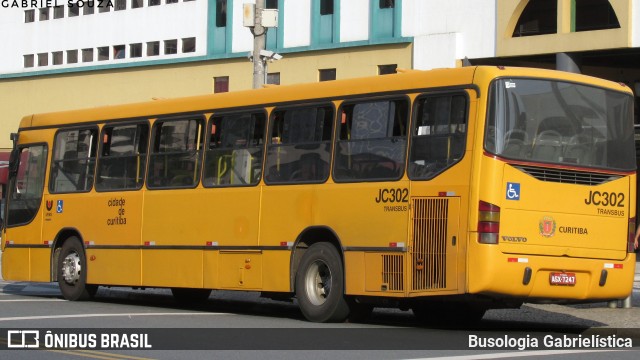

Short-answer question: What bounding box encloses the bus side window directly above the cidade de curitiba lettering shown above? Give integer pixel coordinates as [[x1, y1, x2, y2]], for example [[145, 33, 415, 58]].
[[96, 123, 149, 191]]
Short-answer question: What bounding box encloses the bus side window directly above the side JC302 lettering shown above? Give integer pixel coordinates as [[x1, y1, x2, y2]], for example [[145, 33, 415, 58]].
[[333, 99, 409, 181]]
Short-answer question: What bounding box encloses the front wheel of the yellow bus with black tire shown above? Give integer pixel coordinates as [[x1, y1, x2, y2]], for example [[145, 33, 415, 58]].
[[58, 236, 98, 301]]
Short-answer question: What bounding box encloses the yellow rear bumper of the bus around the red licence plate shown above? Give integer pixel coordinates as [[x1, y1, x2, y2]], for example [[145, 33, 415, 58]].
[[467, 245, 636, 302]]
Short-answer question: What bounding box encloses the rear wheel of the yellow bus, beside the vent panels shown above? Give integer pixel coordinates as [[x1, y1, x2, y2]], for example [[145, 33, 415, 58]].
[[295, 243, 349, 322]]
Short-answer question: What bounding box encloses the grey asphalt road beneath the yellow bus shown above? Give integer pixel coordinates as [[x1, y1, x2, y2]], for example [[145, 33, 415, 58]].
[[0, 253, 640, 359]]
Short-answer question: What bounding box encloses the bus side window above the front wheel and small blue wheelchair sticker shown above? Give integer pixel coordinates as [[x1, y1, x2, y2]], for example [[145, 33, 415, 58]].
[[49, 128, 98, 193]]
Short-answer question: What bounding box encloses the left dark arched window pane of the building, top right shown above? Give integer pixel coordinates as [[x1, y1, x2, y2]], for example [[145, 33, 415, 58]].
[[513, 0, 558, 37]]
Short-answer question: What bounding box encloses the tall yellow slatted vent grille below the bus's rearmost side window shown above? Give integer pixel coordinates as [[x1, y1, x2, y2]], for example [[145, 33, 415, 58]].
[[411, 198, 449, 290]]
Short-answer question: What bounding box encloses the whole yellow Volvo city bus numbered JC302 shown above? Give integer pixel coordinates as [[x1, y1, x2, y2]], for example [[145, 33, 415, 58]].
[[2, 67, 636, 322]]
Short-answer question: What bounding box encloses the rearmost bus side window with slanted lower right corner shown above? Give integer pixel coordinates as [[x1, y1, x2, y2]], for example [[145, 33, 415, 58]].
[[408, 94, 467, 179]]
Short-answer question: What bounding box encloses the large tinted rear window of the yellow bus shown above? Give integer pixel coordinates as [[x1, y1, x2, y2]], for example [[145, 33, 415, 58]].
[[484, 78, 636, 171]]
